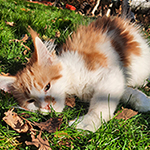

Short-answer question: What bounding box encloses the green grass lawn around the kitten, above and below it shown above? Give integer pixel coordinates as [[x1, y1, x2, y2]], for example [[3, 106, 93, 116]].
[[0, 0, 150, 150]]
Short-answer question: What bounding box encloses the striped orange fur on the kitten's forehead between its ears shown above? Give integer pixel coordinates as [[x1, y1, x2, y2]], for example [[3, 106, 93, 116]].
[[11, 60, 62, 107]]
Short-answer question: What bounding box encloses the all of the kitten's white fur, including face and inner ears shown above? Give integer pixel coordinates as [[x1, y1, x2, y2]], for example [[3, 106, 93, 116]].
[[0, 18, 150, 131]]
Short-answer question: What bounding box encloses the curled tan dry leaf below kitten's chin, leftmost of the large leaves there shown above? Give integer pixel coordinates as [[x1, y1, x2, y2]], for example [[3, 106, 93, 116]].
[[3, 109, 33, 133]]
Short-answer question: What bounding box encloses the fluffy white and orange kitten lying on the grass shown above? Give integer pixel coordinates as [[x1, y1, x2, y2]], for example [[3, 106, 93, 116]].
[[0, 17, 150, 131]]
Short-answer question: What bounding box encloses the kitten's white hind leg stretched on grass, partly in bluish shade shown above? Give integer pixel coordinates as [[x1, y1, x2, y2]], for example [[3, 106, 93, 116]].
[[121, 87, 150, 112]]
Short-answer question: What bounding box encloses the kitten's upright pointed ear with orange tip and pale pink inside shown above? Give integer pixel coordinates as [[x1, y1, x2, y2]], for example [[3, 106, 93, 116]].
[[28, 27, 55, 65]]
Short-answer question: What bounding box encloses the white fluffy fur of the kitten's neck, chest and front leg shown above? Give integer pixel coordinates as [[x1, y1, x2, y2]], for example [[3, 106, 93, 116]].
[[53, 49, 125, 131]]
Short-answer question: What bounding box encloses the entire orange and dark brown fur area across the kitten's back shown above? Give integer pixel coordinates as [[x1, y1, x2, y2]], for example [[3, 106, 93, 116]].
[[63, 17, 141, 67]]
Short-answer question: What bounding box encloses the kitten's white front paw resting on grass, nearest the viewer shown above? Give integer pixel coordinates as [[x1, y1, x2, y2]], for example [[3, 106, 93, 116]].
[[69, 115, 100, 132]]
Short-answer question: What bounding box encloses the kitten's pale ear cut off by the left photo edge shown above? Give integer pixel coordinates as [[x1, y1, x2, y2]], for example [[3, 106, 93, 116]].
[[0, 75, 16, 93]]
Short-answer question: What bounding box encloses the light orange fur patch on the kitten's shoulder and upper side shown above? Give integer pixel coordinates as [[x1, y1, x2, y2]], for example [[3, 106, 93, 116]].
[[63, 26, 108, 70]]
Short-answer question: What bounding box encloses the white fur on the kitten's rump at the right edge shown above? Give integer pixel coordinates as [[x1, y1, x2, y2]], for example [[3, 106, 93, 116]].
[[127, 30, 150, 87]]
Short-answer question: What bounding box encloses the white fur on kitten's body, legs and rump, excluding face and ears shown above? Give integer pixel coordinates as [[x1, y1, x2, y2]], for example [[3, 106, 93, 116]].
[[45, 27, 150, 131]]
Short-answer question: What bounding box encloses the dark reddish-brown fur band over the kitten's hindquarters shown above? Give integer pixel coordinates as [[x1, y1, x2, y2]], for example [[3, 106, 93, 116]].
[[90, 17, 141, 67]]
